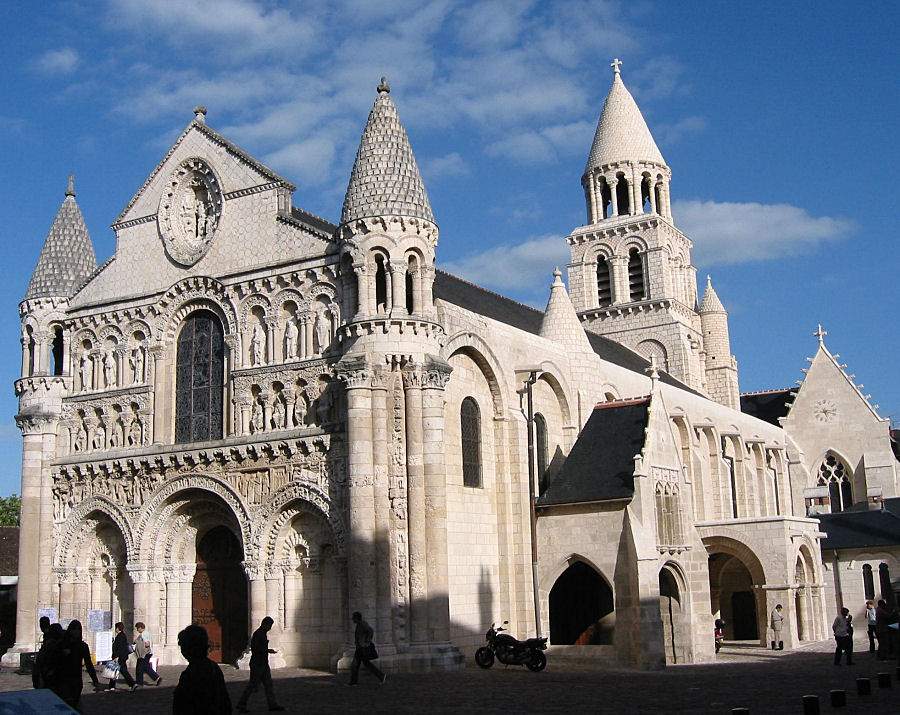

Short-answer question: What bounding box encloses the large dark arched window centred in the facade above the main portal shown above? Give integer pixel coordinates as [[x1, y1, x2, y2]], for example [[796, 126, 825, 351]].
[[175, 310, 225, 443]]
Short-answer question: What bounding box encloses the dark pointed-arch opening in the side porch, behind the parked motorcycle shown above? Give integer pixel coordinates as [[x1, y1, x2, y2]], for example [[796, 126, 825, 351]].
[[550, 561, 615, 645]]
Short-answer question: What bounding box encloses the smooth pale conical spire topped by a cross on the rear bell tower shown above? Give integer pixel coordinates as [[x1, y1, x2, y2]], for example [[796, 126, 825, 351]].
[[584, 59, 666, 174]]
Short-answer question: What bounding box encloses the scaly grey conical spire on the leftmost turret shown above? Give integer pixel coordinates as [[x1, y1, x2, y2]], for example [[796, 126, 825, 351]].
[[25, 176, 97, 300]]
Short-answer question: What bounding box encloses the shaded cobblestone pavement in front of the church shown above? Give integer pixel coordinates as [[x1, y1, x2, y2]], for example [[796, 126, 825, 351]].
[[0, 642, 900, 715]]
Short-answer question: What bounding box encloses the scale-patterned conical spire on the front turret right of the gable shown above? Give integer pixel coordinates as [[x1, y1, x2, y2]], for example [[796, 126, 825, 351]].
[[341, 77, 434, 223]]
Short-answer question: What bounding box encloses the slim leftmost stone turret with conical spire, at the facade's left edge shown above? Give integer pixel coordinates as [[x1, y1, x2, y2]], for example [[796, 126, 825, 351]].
[[4, 176, 97, 665]]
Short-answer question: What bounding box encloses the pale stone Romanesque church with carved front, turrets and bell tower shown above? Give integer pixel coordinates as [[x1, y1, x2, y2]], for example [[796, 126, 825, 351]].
[[5, 63, 897, 669]]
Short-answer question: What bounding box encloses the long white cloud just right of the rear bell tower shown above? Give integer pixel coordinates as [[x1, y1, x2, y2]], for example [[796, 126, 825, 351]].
[[672, 200, 854, 266]]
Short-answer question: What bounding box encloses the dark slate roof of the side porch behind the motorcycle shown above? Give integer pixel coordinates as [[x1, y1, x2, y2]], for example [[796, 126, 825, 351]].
[[537, 397, 650, 507]]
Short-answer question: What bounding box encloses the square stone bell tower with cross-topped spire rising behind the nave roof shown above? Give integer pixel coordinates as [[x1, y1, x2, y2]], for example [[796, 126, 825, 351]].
[[567, 59, 706, 390]]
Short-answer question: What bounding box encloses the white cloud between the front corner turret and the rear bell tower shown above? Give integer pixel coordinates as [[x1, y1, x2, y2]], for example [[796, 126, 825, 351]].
[[441, 235, 569, 301]]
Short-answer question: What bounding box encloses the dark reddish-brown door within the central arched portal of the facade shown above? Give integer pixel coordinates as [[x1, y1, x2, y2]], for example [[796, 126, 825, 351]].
[[191, 526, 247, 663]]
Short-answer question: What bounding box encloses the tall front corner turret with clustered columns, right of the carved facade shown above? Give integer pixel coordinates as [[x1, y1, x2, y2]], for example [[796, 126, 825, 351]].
[[336, 78, 462, 670]]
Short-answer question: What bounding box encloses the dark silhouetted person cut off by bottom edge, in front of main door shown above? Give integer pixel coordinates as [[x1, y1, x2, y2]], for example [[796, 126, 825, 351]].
[[172, 625, 231, 715]]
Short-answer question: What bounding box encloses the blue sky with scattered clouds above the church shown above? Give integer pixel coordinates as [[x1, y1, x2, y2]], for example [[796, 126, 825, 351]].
[[0, 0, 900, 493]]
